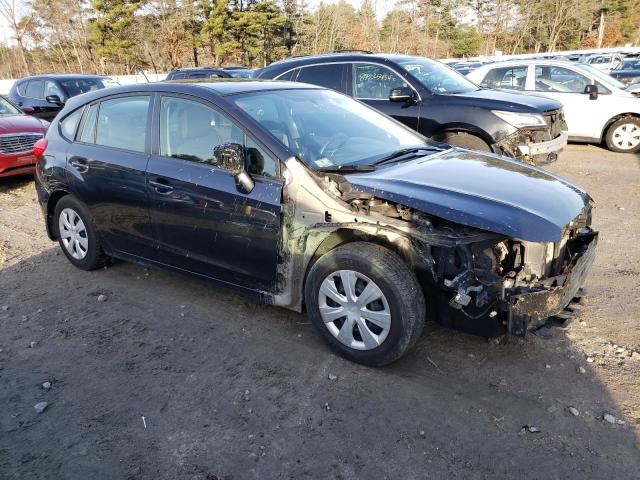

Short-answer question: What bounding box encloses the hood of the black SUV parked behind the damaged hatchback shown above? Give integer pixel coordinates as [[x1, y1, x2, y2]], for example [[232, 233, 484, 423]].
[[456, 88, 562, 113]]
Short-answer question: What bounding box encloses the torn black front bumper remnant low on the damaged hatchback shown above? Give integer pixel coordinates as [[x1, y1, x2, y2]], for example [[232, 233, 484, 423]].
[[503, 231, 598, 336]]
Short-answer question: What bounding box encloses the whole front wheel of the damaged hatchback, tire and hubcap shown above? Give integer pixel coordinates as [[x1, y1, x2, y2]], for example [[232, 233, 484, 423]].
[[305, 242, 425, 366]]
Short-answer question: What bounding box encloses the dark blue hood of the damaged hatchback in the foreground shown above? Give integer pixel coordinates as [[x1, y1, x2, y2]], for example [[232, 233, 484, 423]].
[[345, 148, 591, 242]]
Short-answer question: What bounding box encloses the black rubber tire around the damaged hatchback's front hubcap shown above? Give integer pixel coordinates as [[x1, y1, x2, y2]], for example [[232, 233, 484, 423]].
[[305, 242, 426, 367]]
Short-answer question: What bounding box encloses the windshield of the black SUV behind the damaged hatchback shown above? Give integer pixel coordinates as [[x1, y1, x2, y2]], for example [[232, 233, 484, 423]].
[[396, 57, 478, 94]]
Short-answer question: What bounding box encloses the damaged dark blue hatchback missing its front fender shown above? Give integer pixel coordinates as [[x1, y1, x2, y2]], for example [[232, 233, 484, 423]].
[[36, 81, 597, 365]]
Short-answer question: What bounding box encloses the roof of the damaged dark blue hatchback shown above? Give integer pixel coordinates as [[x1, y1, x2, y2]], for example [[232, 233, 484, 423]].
[[67, 78, 325, 108]]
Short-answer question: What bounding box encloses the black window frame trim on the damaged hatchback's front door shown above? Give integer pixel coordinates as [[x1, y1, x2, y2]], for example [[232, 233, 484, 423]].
[[150, 92, 282, 181]]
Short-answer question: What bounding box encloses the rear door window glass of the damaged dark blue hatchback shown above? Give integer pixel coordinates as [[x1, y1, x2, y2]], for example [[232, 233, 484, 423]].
[[96, 95, 151, 152]]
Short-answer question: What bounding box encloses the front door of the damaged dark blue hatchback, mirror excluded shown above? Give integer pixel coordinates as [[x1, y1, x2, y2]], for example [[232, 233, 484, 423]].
[[147, 96, 282, 290]]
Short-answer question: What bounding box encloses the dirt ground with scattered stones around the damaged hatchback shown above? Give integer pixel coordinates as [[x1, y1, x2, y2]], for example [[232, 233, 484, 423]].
[[0, 146, 640, 480]]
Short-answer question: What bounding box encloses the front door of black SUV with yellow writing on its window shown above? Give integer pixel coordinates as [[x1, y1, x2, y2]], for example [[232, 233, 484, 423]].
[[351, 63, 420, 130]]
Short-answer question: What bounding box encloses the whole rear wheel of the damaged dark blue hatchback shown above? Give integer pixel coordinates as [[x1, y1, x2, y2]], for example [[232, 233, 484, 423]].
[[54, 195, 109, 270]]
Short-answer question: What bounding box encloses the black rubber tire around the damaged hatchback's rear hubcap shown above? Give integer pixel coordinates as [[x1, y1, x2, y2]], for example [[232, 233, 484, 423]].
[[53, 195, 109, 270]]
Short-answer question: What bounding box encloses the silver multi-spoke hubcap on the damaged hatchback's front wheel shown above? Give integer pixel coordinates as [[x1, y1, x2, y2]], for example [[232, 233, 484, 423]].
[[318, 270, 391, 350]]
